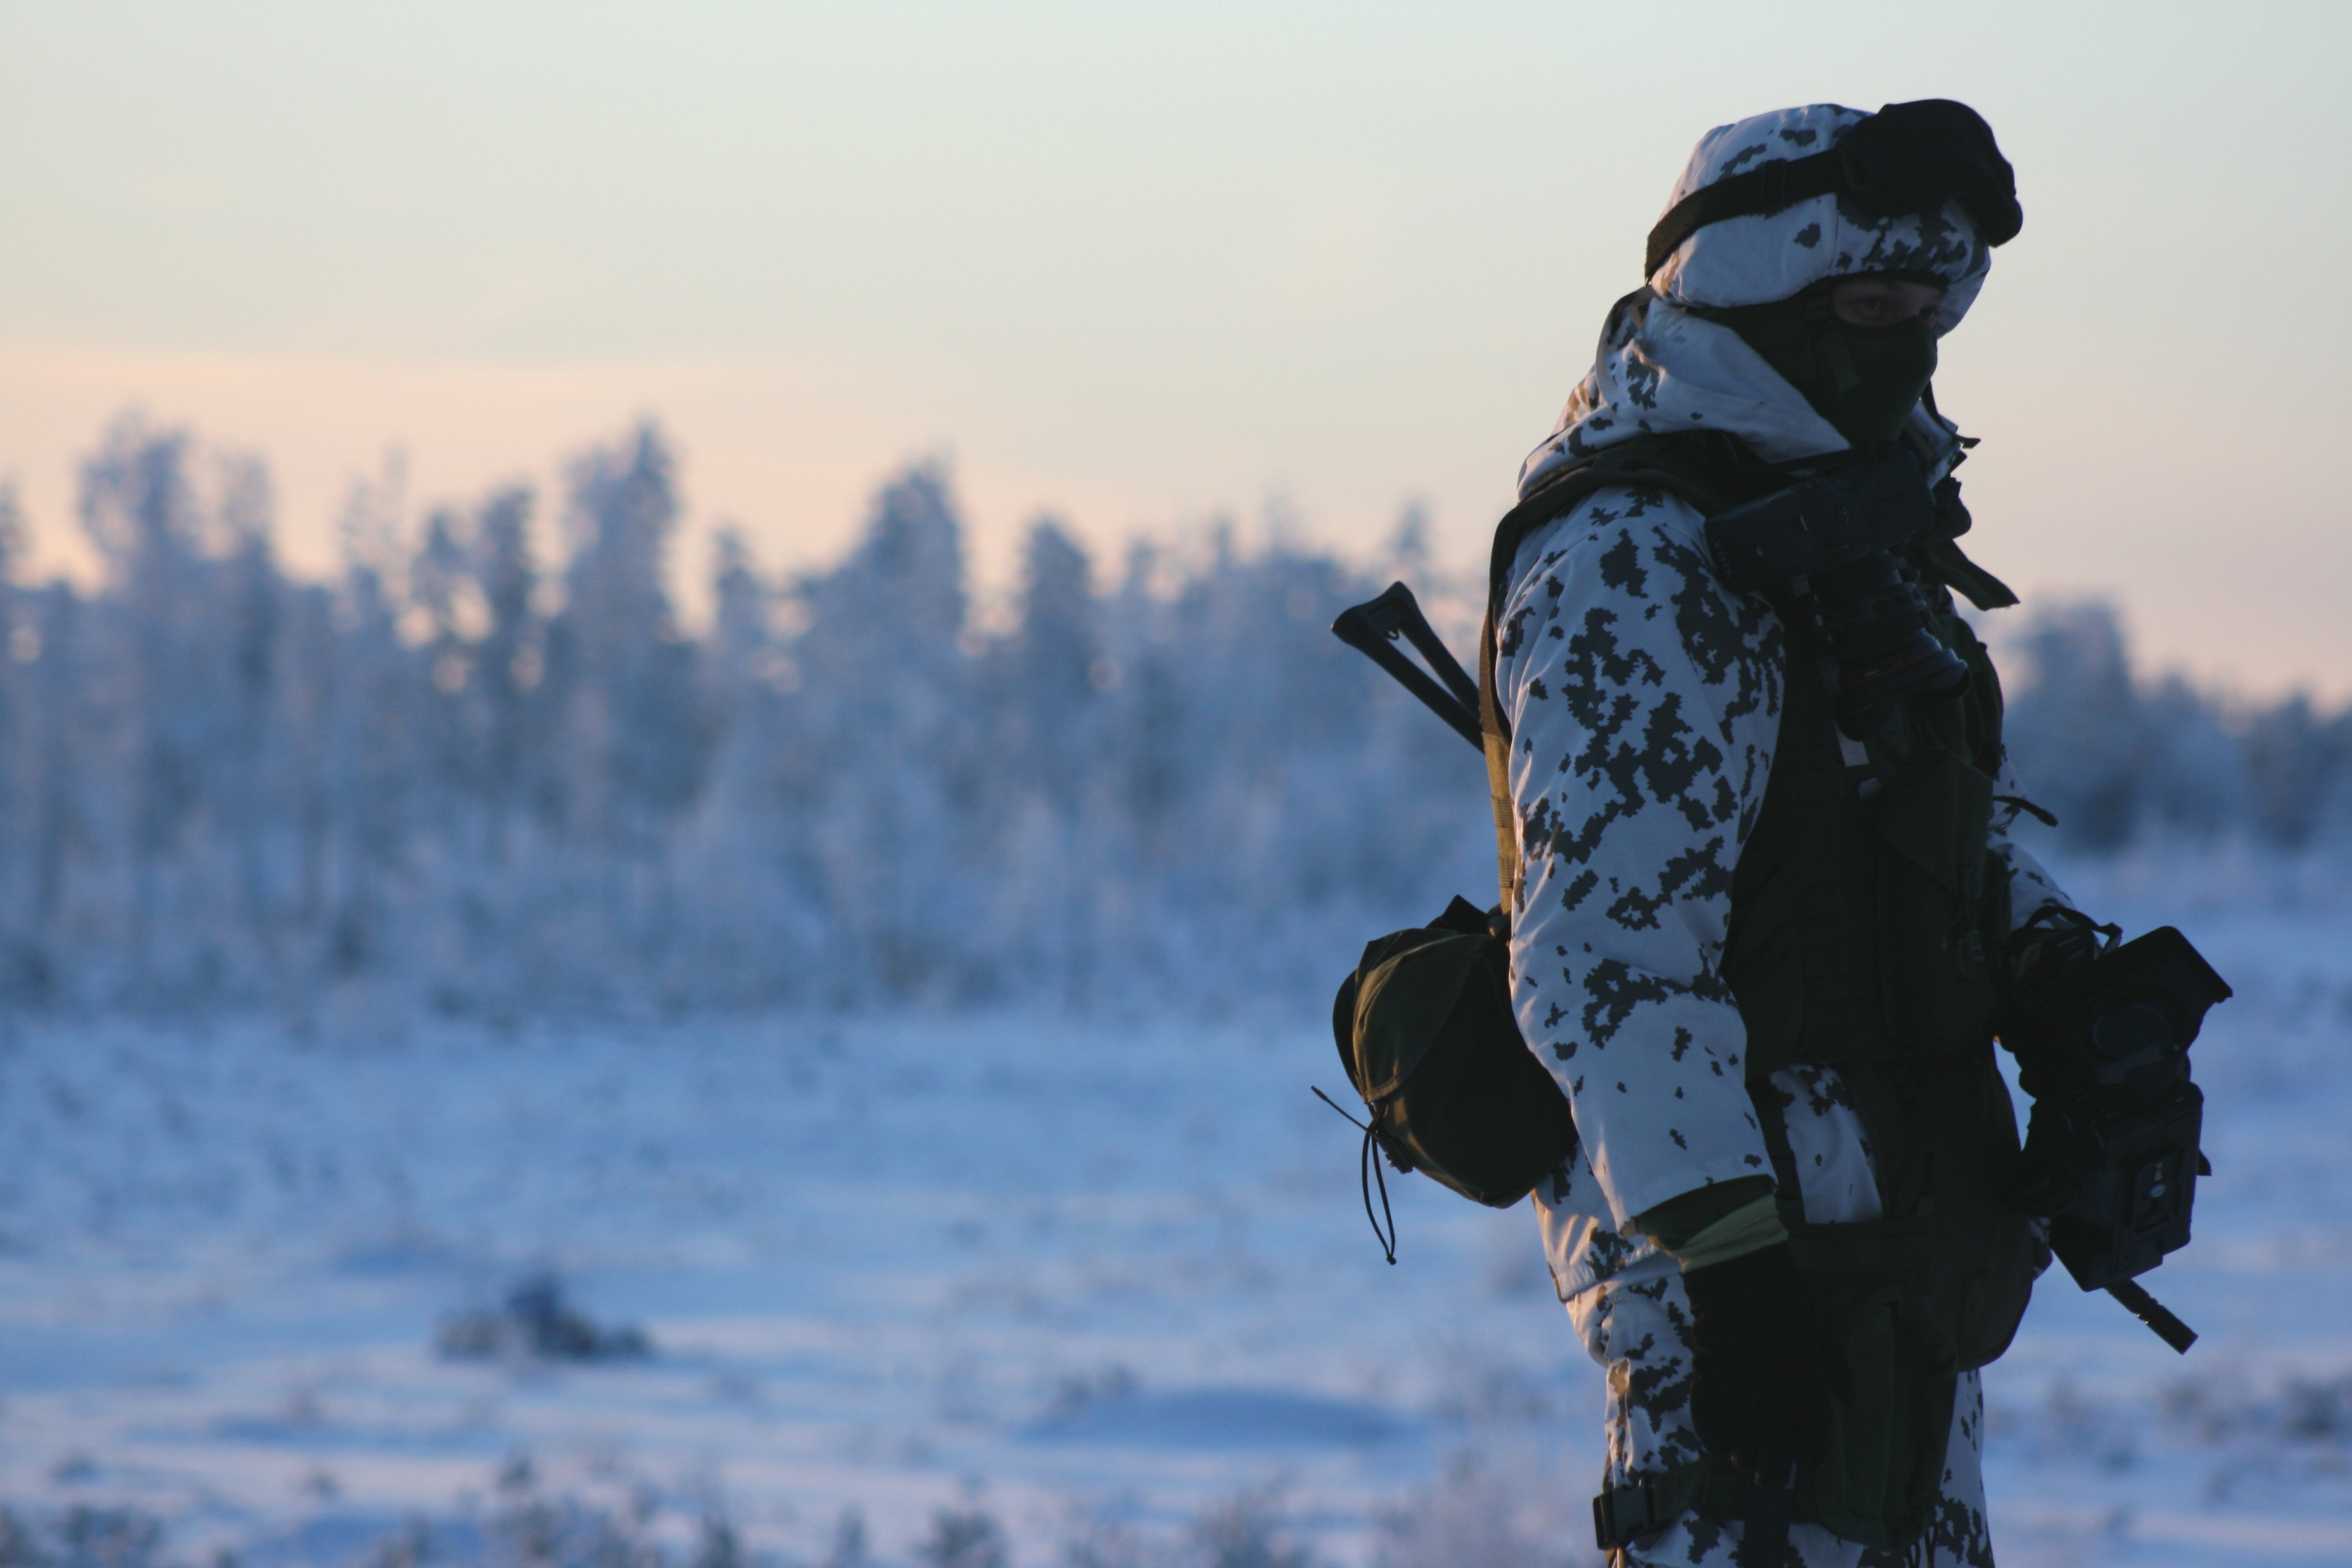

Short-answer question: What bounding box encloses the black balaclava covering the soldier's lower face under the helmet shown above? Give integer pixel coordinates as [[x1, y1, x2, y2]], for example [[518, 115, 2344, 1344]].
[[1700, 273, 1942, 446]]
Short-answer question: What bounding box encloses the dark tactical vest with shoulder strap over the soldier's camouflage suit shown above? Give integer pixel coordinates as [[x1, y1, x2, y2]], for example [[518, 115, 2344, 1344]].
[[1480, 433, 2042, 1549]]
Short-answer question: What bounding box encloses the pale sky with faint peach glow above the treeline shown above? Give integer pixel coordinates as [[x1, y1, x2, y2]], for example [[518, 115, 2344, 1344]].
[[0, 0, 2352, 696]]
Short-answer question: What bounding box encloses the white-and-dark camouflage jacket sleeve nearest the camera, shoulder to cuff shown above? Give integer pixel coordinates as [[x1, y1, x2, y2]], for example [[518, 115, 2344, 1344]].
[[1496, 489, 1783, 1229]]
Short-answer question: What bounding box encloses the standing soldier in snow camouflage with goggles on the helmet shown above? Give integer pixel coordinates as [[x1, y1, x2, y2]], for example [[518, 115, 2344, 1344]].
[[1481, 101, 2068, 1568]]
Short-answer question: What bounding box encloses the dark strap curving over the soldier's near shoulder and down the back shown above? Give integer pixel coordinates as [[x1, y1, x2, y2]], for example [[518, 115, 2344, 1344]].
[[1477, 430, 1771, 915]]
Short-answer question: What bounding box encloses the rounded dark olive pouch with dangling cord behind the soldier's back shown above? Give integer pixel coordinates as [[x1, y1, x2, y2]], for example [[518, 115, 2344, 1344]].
[[1331, 898, 1576, 1208]]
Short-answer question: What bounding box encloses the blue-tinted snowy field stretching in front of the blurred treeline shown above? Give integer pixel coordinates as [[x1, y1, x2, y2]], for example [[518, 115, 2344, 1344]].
[[0, 858, 2352, 1568]]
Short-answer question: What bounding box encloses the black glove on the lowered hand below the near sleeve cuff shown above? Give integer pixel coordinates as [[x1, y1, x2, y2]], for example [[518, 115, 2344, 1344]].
[[1682, 1241, 1835, 1486]]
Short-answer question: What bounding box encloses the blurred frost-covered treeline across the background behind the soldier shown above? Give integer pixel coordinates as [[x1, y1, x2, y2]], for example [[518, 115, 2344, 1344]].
[[0, 423, 2352, 1018]]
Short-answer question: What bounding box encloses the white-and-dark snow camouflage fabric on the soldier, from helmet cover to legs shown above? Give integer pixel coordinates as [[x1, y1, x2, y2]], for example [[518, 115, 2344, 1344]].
[[1496, 106, 2065, 1568]]
